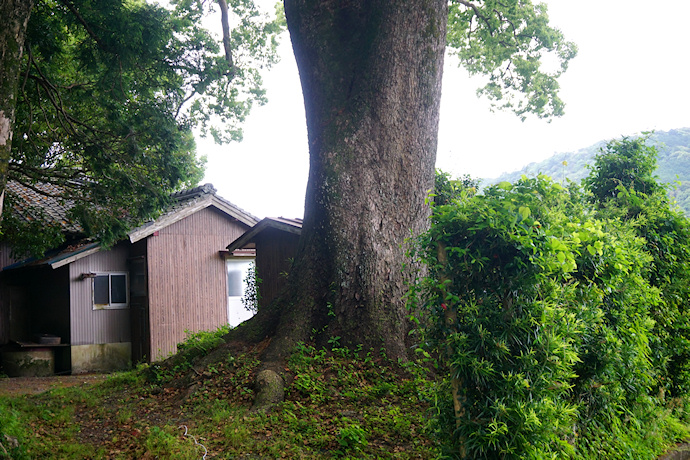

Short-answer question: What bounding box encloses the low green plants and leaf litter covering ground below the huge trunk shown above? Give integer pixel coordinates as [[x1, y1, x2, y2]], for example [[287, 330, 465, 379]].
[[0, 331, 438, 459]]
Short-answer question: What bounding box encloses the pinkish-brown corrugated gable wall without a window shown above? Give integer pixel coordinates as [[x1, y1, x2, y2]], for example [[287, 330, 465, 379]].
[[147, 208, 248, 361]]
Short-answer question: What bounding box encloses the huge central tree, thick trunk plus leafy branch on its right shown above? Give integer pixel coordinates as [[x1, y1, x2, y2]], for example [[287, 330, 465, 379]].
[[226, 0, 576, 378]]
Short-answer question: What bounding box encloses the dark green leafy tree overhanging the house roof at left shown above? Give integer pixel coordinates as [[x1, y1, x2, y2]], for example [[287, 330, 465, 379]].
[[0, 0, 280, 253]]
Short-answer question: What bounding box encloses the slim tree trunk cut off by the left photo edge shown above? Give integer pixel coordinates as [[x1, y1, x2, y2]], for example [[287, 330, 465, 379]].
[[0, 0, 33, 221]]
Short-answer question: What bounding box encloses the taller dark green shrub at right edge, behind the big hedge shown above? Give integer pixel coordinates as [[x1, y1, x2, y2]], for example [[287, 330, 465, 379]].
[[584, 136, 690, 397]]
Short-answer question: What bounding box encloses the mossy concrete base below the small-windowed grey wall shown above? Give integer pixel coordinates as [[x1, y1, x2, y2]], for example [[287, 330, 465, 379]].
[[72, 342, 132, 374]]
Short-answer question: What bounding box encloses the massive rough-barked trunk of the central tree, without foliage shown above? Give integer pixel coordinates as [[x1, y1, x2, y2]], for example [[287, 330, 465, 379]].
[[264, 0, 448, 357]]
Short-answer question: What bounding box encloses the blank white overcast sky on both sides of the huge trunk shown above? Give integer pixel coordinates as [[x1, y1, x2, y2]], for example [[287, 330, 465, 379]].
[[197, 0, 690, 217]]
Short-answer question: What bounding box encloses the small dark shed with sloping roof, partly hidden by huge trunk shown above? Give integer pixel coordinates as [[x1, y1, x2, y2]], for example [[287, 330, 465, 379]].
[[227, 217, 302, 308]]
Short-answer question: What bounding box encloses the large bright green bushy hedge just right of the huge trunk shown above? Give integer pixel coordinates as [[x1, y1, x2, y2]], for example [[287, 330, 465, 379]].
[[410, 171, 678, 458]]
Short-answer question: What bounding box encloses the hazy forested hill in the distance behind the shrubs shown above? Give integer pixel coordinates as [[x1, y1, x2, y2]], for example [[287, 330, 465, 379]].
[[483, 128, 690, 216]]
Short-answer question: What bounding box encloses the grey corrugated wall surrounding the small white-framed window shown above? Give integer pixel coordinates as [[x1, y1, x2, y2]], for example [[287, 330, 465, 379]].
[[69, 242, 131, 345]]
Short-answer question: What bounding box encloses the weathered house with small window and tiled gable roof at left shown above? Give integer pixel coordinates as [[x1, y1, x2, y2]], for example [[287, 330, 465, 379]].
[[0, 184, 257, 373]]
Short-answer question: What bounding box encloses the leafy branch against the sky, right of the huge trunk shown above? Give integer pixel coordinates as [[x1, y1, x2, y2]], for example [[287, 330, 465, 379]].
[[448, 0, 577, 120]]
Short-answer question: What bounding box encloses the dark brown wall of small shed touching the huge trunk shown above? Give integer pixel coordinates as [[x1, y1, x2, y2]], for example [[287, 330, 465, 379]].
[[256, 228, 299, 308]]
